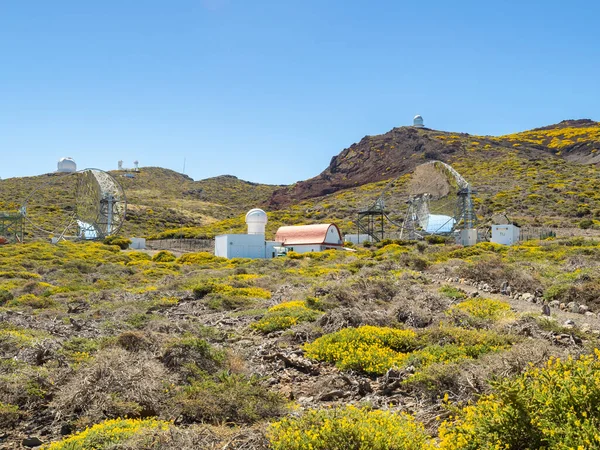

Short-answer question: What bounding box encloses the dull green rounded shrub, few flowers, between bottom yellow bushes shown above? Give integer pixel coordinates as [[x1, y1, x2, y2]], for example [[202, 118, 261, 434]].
[[174, 374, 286, 424]]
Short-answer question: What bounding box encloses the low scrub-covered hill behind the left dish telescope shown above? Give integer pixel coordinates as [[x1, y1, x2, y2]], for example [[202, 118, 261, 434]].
[[0, 167, 280, 236]]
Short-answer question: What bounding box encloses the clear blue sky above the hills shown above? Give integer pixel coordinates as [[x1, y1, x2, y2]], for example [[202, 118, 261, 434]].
[[0, 0, 600, 184]]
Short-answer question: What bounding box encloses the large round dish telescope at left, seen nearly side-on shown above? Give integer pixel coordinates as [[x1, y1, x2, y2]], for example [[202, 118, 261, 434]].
[[21, 169, 127, 240]]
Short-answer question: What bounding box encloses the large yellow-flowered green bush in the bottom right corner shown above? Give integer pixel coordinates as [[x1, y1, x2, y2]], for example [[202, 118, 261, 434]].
[[439, 350, 600, 450]]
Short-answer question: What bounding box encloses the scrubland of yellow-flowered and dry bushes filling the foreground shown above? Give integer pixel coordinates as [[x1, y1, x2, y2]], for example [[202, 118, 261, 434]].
[[0, 227, 600, 450]]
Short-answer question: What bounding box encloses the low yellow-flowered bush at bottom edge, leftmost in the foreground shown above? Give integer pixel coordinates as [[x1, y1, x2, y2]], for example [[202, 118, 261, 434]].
[[42, 419, 170, 450]]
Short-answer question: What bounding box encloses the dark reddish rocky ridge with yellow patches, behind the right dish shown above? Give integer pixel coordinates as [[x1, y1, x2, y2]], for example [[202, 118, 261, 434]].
[[270, 119, 600, 208]]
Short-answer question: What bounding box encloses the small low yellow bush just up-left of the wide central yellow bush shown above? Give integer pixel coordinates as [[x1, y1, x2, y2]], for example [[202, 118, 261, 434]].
[[252, 300, 322, 333]]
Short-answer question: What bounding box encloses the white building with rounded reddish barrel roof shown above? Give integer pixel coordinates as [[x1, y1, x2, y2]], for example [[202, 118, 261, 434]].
[[275, 223, 344, 253]]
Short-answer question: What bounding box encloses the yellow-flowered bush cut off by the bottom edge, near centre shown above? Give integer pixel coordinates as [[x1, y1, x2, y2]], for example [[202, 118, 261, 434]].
[[268, 405, 430, 450]]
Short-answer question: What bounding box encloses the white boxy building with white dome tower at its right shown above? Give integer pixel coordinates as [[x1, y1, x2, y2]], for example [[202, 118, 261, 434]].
[[215, 208, 281, 258]]
